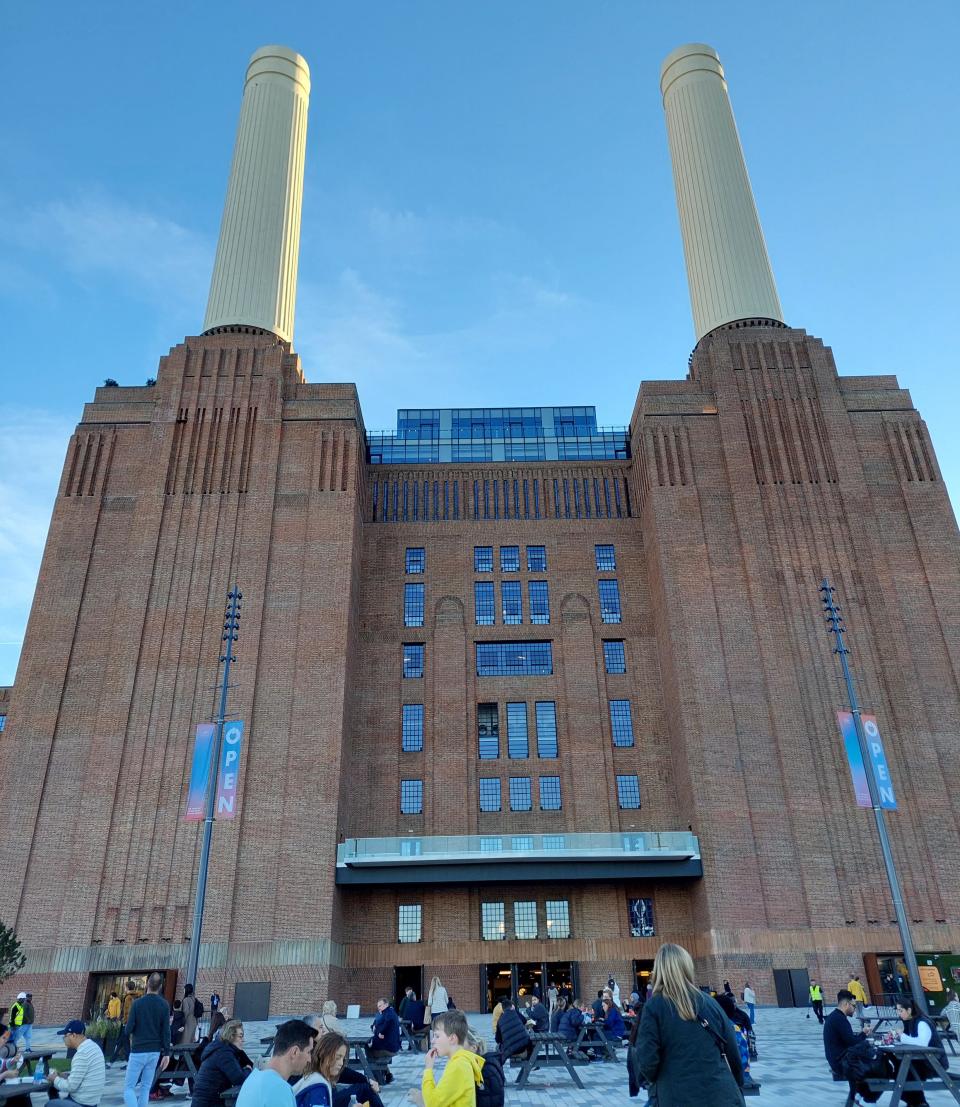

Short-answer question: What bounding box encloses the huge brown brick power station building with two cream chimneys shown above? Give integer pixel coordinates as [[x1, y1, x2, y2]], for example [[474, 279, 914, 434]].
[[0, 48, 960, 1022]]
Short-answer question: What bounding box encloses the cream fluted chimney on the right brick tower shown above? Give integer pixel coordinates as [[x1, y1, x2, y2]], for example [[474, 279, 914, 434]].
[[660, 43, 783, 341]]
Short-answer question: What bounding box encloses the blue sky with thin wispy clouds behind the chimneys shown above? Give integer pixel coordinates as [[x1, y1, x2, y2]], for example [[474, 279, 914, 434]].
[[0, 0, 960, 683]]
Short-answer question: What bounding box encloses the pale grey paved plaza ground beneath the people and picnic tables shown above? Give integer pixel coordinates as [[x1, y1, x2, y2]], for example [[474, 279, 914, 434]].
[[22, 1008, 960, 1107]]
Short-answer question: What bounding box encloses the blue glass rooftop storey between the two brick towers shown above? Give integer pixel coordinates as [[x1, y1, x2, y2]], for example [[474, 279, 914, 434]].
[[367, 407, 630, 465]]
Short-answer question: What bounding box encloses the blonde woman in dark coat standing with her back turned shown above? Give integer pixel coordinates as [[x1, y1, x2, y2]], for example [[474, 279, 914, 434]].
[[632, 943, 744, 1107]]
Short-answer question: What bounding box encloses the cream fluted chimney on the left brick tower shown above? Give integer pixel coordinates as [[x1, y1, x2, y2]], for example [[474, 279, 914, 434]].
[[204, 46, 310, 342]]
